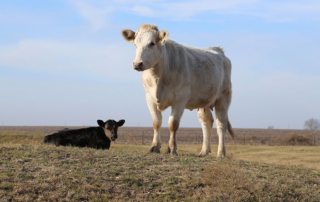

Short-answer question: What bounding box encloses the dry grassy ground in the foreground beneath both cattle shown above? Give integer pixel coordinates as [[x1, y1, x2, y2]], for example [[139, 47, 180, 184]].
[[0, 131, 320, 201]]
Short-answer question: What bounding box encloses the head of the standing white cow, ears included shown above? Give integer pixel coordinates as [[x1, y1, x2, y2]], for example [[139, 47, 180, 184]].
[[121, 24, 169, 71]]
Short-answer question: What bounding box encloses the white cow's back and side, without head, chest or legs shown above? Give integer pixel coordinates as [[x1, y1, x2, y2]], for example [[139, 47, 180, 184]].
[[166, 40, 231, 109]]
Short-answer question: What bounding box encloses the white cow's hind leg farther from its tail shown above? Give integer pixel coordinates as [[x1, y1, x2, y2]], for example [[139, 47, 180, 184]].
[[198, 108, 213, 156]]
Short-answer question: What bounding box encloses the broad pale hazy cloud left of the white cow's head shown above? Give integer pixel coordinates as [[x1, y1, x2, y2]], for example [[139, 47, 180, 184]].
[[0, 40, 139, 81]]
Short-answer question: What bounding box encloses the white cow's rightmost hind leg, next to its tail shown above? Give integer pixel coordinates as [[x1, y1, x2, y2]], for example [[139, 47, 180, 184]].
[[215, 91, 231, 158]]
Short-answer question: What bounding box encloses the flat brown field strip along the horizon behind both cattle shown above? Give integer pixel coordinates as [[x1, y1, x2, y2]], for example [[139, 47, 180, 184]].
[[0, 126, 320, 146]]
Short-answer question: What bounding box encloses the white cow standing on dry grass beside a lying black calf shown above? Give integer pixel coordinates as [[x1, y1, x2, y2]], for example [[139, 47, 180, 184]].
[[121, 24, 234, 157]]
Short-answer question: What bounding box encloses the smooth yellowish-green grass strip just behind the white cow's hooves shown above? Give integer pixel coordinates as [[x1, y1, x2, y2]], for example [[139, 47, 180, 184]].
[[113, 144, 320, 172]]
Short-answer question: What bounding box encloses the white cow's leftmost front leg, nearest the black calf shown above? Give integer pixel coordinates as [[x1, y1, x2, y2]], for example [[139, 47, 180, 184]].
[[146, 95, 162, 153]]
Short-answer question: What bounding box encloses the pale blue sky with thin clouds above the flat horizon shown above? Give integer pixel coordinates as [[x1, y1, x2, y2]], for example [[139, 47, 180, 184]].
[[0, 0, 320, 129]]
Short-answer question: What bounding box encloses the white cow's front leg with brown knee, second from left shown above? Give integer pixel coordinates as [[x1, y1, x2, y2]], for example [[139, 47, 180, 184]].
[[167, 104, 185, 154]]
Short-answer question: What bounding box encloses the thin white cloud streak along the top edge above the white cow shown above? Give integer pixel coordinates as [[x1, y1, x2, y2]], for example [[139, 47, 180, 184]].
[[131, 0, 320, 22]]
